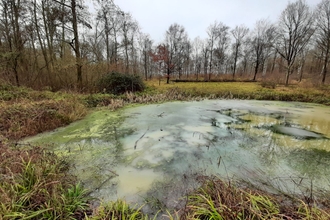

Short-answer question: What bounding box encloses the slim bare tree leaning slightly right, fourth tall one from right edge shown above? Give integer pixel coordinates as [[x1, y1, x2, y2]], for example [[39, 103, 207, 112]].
[[231, 25, 249, 78]]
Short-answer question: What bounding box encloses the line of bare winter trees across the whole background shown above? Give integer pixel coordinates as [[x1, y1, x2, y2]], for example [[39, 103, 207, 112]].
[[0, 0, 330, 90]]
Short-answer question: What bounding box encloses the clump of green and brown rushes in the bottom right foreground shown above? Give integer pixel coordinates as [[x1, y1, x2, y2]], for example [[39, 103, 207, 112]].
[[181, 177, 330, 220]]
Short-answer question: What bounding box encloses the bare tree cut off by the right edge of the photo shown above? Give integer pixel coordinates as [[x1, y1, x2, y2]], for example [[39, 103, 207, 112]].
[[315, 0, 330, 84]]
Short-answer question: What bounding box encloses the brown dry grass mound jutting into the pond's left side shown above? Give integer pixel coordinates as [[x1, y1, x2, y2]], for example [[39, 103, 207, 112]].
[[0, 100, 87, 140]]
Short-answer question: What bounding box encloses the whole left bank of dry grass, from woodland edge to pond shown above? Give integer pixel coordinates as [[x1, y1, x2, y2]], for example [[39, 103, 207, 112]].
[[0, 85, 88, 140]]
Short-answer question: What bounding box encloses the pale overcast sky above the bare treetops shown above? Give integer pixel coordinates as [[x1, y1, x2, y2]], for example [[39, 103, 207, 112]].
[[114, 0, 321, 43]]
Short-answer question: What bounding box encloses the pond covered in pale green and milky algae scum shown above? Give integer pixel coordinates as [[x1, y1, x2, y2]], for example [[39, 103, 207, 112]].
[[25, 100, 330, 211]]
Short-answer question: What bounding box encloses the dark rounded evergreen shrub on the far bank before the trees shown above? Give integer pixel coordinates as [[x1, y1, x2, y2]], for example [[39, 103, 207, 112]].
[[97, 72, 145, 95]]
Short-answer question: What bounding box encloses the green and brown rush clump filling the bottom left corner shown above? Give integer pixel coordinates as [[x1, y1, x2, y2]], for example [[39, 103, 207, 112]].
[[0, 145, 89, 220]]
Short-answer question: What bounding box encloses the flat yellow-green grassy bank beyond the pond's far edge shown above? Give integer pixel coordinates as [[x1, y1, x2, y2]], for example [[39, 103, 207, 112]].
[[147, 81, 330, 105]]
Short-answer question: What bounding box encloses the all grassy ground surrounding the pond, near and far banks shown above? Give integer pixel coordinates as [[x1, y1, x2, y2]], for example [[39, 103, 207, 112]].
[[0, 80, 330, 220]]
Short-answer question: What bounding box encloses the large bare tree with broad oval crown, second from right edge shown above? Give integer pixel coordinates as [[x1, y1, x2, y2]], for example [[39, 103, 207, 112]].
[[276, 0, 314, 86]]
